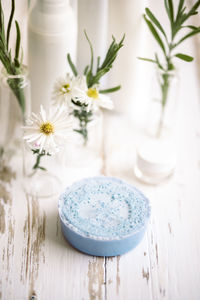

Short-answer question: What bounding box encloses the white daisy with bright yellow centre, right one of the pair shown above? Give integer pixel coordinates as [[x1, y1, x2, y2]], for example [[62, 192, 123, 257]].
[[73, 76, 114, 110]]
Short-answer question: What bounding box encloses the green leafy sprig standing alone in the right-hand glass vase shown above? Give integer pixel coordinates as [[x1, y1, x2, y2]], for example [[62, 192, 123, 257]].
[[138, 0, 200, 135]]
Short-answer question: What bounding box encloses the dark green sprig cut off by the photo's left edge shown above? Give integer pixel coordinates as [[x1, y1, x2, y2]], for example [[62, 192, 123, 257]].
[[0, 0, 25, 114]]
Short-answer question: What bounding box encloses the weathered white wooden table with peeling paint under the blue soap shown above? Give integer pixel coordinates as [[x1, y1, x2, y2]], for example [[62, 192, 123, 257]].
[[0, 0, 200, 300]]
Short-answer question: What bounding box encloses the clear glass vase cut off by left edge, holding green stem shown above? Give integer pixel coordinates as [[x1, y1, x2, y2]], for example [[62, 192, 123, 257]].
[[0, 66, 31, 168]]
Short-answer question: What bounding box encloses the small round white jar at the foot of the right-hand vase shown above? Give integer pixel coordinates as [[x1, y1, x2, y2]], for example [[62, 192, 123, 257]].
[[136, 139, 176, 176]]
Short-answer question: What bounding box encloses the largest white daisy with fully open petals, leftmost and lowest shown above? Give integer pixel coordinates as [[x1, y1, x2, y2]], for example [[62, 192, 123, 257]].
[[24, 105, 72, 154]]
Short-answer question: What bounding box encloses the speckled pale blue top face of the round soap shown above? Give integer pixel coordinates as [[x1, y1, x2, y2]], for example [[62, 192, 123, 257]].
[[59, 176, 150, 240]]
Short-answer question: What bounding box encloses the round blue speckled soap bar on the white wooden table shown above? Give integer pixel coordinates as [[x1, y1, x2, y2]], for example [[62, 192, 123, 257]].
[[59, 176, 150, 256]]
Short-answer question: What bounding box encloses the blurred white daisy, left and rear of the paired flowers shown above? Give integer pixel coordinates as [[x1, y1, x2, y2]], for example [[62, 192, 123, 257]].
[[52, 74, 83, 107]]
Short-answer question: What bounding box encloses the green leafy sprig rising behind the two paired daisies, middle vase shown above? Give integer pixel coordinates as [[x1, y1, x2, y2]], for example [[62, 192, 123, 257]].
[[67, 31, 125, 144]]
